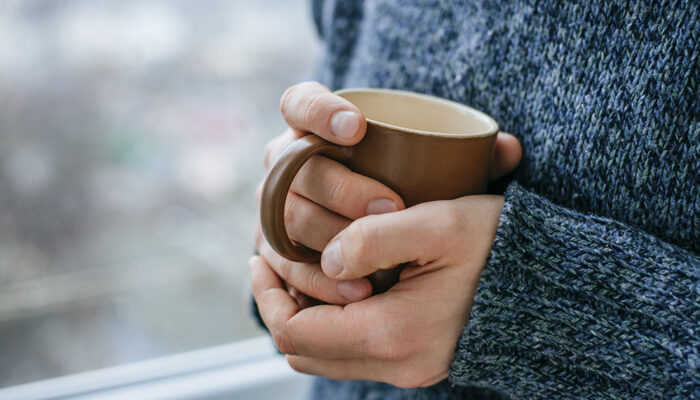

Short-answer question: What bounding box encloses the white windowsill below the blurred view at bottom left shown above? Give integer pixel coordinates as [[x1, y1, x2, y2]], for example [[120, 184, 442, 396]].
[[0, 337, 311, 400]]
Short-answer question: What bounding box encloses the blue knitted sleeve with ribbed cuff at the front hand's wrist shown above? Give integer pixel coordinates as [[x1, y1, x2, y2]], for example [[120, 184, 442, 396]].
[[450, 184, 700, 399]]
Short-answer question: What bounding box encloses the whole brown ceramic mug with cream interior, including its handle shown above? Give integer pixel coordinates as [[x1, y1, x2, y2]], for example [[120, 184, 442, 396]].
[[260, 89, 498, 293]]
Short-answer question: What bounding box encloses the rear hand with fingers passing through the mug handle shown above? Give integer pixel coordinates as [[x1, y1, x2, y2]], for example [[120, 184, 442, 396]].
[[256, 82, 404, 307]]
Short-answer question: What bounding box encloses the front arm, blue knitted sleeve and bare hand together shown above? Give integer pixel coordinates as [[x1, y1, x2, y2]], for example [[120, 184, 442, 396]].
[[251, 182, 700, 399]]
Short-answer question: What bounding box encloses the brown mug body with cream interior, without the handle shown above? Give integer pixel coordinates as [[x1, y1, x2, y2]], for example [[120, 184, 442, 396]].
[[336, 89, 498, 207]]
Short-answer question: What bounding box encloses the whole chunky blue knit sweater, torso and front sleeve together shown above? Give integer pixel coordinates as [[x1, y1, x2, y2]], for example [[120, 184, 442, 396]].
[[268, 0, 700, 399]]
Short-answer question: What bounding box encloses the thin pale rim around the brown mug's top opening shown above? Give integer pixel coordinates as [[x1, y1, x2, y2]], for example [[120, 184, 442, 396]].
[[333, 87, 499, 138]]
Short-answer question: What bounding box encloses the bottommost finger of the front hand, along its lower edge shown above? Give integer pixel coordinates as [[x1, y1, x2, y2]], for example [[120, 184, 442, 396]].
[[286, 355, 442, 388]]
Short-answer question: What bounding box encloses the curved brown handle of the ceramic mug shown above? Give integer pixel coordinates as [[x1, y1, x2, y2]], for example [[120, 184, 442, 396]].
[[260, 134, 350, 263]]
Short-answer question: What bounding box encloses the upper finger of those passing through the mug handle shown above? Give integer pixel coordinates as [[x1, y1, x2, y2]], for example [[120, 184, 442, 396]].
[[292, 156, 404, 220]]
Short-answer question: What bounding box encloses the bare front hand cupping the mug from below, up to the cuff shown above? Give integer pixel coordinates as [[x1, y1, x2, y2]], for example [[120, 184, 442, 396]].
[[249, 195, 504, 388]]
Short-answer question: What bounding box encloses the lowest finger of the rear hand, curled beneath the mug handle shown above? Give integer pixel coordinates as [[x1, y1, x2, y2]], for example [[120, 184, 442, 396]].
[[258, 240, 372, 305]]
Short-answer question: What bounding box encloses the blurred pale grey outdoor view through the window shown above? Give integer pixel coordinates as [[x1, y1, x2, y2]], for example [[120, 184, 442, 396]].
[[0, 0, 319, 387]]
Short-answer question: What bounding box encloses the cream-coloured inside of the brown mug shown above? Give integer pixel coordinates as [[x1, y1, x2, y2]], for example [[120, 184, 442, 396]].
[[336, 89, 498, 137]]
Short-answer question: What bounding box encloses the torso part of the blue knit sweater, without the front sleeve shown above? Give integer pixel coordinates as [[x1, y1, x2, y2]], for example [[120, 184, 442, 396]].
[[314, 0, 700, 252]]
